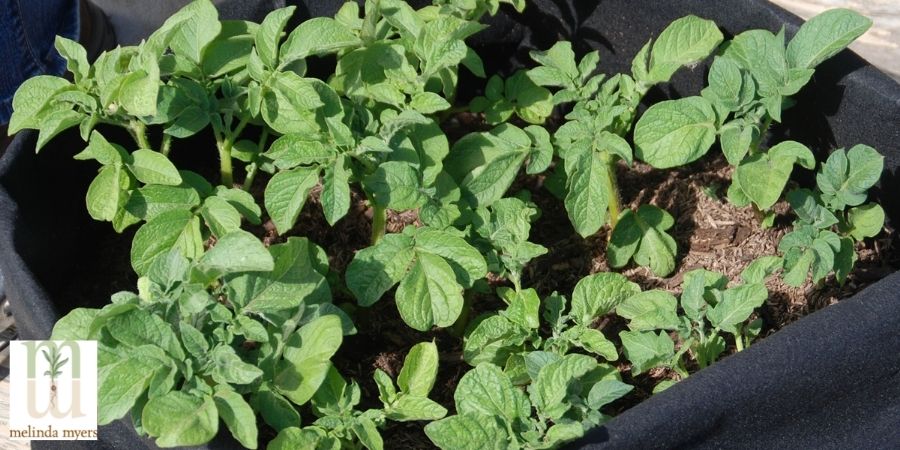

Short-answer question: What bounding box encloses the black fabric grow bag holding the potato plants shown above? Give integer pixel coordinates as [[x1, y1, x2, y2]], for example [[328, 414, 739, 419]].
[[0, 0, 900, 449]]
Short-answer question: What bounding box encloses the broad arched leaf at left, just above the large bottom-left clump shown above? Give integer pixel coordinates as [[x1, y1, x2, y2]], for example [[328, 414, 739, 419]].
[[131, 209, 203, 275]]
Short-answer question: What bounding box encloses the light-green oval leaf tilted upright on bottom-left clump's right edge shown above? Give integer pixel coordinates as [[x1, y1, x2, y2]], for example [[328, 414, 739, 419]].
[[274, 315, 343, 405]]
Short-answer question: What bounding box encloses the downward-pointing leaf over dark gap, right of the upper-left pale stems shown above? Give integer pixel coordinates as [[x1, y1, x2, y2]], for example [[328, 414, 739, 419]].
[[264, 167, 319, 234]]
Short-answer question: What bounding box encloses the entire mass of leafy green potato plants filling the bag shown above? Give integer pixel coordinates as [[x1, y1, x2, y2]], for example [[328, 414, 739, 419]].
[[10, 0, 884, 450]]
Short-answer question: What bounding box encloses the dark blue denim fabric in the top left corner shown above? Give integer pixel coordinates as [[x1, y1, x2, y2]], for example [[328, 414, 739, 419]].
[[0, 0, 80, 124]]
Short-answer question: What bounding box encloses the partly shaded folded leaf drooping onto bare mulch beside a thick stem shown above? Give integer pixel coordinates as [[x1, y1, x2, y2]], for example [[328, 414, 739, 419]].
[[607, 205, 677, 277]]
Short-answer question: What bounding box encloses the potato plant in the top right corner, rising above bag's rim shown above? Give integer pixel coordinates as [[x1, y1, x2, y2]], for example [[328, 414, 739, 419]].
[[634, 9, 872, 225]]
